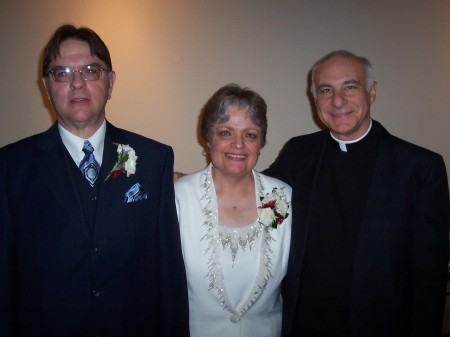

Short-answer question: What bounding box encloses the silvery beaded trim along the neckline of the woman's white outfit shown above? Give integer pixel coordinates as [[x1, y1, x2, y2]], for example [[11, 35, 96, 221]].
[[201, 165, 275, 323]]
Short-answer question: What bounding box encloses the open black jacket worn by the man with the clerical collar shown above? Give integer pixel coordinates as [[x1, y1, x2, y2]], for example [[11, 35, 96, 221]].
[[265, 121, 450, 337]]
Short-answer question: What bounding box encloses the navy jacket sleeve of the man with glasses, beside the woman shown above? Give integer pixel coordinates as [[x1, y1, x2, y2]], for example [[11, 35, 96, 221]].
[[159, 149, 189, 337]]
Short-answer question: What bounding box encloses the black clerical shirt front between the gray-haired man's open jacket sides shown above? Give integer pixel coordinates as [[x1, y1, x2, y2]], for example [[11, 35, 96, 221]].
[[293, 125, 379, 337]]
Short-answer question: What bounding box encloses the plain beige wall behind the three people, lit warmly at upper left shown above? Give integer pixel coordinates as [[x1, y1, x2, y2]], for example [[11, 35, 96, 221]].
[[0, 0, 450, 181]]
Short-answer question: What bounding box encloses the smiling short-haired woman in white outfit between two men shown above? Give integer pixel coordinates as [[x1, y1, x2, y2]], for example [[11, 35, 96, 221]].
[[175, 84, 292, 337]]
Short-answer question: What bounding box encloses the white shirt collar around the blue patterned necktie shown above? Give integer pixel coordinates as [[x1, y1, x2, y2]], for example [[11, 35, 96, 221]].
[[58, 120, 106, 166]]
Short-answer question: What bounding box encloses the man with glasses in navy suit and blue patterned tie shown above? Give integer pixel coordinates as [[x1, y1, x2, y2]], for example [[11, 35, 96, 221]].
[[0, 25, 189, 337]]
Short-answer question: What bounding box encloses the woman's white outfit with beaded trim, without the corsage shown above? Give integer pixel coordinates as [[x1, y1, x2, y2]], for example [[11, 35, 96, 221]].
[[175, 165, 292, 337]]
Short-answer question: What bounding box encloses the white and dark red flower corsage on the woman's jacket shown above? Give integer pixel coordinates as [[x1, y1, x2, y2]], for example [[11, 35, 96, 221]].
[[258, 187, 289, 228]]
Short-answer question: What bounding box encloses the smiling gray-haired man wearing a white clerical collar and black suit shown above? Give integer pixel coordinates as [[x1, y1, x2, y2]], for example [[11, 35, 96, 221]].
[[267, 51, 449, 337]]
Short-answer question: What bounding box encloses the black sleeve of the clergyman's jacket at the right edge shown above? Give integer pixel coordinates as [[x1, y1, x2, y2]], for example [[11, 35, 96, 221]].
[[410, 156, 450, 337]]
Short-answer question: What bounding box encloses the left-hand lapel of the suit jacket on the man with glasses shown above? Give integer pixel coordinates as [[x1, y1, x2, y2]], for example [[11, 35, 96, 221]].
[[36, 123, 90, 238]]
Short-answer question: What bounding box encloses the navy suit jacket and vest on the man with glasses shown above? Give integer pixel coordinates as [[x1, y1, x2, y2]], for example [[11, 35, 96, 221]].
[[0, 123, 189, 337]]
